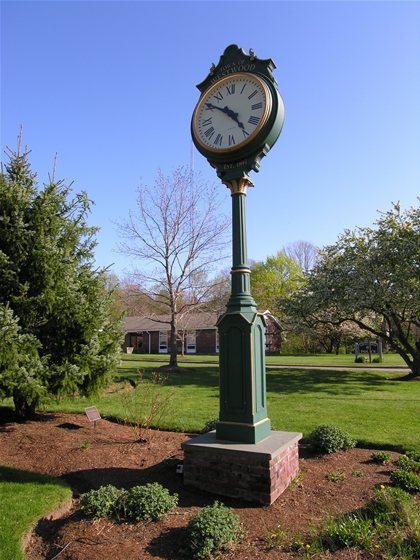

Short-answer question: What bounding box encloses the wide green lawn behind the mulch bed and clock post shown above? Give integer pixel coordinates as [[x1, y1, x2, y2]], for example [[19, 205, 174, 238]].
[[37, 356, 420, 456]]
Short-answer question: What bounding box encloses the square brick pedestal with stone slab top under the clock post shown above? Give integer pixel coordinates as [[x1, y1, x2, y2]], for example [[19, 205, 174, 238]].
[[181, 431, 302, 505]]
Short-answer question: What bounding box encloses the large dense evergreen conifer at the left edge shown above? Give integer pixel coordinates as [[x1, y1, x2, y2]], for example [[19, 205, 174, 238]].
[[0, 139, 122, 416]]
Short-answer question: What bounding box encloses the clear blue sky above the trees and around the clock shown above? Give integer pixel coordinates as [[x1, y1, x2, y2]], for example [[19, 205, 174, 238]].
[[1, 0, 420, 276]]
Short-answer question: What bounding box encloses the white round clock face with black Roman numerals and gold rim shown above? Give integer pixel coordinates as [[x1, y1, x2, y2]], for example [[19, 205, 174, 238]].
[[192, 73, 272, 153]]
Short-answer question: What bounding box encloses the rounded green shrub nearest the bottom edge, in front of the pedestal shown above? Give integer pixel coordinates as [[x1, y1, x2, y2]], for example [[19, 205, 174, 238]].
[[180, 501, 241, 559]]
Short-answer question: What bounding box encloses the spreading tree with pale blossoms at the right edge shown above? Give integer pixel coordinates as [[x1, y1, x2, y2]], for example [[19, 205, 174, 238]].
[[282, 204, 420, 379]]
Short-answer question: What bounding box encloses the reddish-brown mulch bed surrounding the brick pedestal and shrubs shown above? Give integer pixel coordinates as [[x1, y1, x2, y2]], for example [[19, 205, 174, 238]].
[[0, 414, 398, 560]]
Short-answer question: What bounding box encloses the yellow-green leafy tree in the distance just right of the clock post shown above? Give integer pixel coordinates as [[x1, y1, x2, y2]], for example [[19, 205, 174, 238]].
[[251, 251, 303, 317]]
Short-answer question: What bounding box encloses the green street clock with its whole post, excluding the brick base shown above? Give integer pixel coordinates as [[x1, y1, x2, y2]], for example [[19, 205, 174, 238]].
[[191, 45, 284, 444]]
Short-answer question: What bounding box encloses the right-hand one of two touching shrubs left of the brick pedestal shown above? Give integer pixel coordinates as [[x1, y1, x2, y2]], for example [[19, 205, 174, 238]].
[[124, 482, 178, 521]]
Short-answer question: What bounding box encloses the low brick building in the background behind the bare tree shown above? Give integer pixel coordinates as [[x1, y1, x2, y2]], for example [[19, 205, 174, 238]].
[[123, 311, 283, 354]]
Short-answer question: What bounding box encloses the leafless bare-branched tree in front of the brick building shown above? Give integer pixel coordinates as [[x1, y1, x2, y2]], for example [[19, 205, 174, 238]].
[[118, 168, 229, 368]]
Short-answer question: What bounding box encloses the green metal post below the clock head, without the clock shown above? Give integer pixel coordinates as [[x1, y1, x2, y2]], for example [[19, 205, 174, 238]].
[[216, 175, 271, 443]]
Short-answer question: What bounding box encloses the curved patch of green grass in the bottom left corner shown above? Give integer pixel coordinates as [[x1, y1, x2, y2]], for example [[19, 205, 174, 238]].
[[0, 466, 72, 560]]
